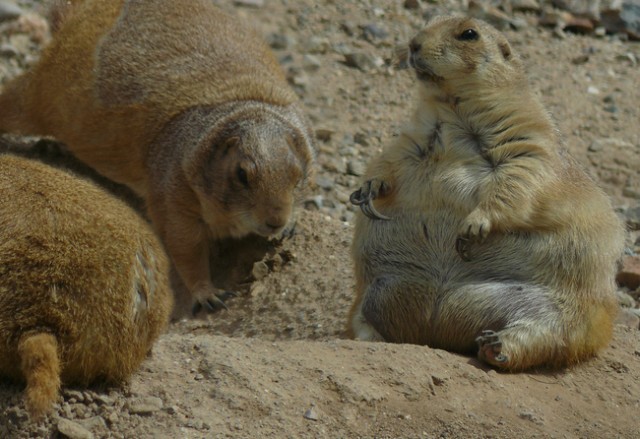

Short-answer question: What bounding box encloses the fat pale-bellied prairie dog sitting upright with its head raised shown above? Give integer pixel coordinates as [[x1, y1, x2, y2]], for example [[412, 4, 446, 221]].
[[349, 17, 625, 371]]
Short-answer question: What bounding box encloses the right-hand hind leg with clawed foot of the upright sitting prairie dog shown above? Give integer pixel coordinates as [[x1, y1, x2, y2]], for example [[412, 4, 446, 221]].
[[434, 282, 582, 371]]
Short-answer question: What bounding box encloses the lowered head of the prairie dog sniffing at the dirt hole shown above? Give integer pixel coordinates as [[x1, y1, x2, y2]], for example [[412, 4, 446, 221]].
[[186, 105, 312, 237]]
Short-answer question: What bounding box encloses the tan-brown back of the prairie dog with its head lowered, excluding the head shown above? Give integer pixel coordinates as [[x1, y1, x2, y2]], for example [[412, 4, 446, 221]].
[[0, 0, 297, 195]]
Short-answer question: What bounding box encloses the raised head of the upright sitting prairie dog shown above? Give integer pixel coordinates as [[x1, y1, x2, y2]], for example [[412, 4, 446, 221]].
[[404, 16, 523, 89]]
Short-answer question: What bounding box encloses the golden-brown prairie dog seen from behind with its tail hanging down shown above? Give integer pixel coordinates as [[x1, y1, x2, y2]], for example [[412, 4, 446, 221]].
[[0, 155, 173, 418]]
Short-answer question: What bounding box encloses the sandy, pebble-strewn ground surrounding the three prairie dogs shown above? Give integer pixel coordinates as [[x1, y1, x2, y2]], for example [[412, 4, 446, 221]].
[[0, 0, 640, 439]]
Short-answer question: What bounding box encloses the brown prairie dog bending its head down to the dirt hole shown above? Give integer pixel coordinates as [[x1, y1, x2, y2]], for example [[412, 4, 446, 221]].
[[0, 0, 314, 316]]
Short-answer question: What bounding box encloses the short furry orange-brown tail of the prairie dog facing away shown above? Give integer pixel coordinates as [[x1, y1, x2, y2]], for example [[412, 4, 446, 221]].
[[18, 333, 60, 419]]
